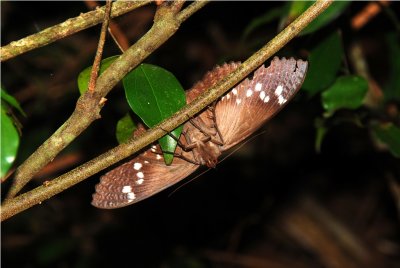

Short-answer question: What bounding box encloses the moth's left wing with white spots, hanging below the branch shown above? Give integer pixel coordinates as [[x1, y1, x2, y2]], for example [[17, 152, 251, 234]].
[[92, 126, 198, 209]]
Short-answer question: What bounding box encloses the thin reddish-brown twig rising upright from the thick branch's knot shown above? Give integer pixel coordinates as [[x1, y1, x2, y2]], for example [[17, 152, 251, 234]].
[[88, 0, 112, 93]]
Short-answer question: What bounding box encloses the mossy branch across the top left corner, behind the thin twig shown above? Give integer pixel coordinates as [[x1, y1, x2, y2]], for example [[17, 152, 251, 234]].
[[0, 0, 153, 62]]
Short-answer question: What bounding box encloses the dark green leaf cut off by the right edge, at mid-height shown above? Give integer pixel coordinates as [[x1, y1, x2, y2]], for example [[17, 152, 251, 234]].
[[373, 123, 400, 158]]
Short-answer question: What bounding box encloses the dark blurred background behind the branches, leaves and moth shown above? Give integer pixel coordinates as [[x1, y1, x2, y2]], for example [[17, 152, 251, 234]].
[[1, 2, 400, 267]]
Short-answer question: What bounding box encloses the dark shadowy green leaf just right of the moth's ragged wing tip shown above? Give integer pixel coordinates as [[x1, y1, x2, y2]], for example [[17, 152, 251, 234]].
[[303, 32, 343, 96]]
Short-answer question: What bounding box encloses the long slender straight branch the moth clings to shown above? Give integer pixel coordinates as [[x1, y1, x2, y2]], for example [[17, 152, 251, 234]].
[[1, 0, 332, 221]]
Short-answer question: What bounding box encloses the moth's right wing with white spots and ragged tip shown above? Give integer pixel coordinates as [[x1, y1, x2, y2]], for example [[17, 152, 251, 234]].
[[215, 57, 307, 151]]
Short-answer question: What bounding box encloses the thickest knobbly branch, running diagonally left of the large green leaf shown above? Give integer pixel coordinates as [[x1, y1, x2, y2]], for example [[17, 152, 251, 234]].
[[7, 1, 207, 199]]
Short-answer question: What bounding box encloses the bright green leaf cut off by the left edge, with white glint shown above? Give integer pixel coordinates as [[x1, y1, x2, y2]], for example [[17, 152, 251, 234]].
[[0, 105, 19, 177]]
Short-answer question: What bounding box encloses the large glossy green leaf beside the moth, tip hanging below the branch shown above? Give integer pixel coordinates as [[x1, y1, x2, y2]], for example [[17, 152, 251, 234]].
[[122, 64, 186, 165]]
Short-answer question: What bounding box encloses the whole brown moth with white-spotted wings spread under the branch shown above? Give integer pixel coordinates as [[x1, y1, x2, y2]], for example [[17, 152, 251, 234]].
[[92, 57, 308, 209]]
